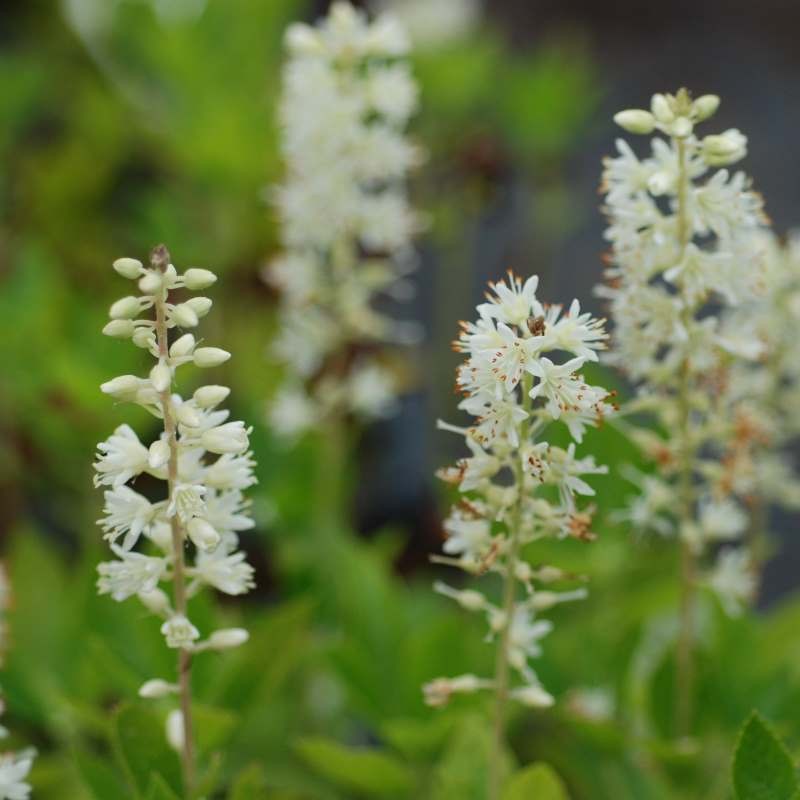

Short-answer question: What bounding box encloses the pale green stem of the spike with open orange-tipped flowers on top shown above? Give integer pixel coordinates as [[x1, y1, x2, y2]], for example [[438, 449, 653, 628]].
[[488, 375, 531, 800]]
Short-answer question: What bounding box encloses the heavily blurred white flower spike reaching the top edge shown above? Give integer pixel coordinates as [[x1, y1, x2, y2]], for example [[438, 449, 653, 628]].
[[265, 2, 420, 436]]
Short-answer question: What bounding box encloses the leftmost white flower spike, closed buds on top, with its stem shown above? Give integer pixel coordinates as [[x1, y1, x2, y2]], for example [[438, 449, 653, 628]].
[[94, 245, 256, 793]]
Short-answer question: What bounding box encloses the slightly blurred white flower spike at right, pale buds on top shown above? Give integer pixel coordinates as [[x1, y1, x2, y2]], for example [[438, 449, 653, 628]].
[[599, 89, 767, 620]]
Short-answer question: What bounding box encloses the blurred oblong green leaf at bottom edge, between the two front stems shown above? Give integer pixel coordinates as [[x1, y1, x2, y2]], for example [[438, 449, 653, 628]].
[[296, 736, 414, 797]]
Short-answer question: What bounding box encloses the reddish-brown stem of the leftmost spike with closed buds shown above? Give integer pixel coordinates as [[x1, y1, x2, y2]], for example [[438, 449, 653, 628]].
[[151, 245, 195, 800]]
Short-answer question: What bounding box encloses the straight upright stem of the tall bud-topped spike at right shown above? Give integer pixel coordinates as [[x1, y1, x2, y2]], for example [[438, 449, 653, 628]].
[[675, 139, 696, 738]]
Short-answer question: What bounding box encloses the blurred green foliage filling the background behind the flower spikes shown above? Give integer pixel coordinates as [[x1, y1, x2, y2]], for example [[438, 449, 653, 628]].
[[0, 0, 800, 800]]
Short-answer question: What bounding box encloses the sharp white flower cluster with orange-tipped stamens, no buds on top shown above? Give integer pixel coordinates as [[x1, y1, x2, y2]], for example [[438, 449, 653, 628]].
[[425, 275, 611, 706]]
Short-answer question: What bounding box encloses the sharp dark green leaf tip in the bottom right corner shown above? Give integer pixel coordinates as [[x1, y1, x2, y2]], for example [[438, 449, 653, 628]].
[[733, 711, 799, 800]]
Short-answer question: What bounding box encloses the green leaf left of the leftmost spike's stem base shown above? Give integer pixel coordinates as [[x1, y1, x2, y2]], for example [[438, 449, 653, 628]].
[[114, 705, 180, 795]]
